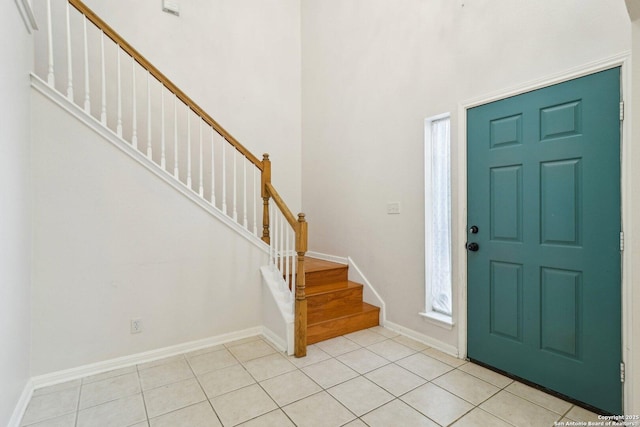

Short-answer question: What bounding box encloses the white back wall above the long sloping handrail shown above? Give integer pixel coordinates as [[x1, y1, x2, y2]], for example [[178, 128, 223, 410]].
[[79, 0, 301, 212]]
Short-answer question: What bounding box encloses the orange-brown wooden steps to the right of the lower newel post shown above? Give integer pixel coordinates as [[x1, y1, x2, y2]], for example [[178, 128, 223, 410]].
[[305, 258, 380, 344]]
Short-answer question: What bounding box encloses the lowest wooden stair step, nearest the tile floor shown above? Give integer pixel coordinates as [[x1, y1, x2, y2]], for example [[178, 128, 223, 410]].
[[307, 302, 380, 344]]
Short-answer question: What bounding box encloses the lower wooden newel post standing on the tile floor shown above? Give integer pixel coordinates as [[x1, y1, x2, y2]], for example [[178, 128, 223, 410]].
[[294, 213, 307, 357]]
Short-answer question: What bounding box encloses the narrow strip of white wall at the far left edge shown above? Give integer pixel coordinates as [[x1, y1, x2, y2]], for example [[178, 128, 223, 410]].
[[0, 2, 32, 425]]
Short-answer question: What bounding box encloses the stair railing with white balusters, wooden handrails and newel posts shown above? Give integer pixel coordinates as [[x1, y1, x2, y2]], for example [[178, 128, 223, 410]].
[[34, 0, 307, 357]]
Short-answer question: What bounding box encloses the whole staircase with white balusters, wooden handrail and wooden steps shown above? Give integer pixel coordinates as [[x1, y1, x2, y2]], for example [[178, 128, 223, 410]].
[[32, 0, 380, 357]]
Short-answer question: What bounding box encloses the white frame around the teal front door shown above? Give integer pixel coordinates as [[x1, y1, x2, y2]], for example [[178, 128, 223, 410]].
[[452, 52, 640, 412]]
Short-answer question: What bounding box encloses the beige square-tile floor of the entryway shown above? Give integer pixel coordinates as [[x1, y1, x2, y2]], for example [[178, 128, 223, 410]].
[[22, 327, 597, 427]]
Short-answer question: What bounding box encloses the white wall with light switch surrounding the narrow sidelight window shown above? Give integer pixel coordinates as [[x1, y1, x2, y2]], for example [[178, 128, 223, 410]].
[[302, 0, 630, 352]]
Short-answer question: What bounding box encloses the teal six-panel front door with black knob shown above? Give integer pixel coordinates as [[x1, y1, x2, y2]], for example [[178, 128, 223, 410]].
[[467, 68, 622, 414]]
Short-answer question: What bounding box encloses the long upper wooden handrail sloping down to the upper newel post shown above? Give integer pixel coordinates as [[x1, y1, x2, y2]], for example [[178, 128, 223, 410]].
[[68, 0, 262, 171]]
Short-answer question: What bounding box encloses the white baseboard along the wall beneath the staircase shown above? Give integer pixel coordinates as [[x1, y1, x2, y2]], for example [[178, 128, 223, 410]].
[[27, 326, 268, 392]]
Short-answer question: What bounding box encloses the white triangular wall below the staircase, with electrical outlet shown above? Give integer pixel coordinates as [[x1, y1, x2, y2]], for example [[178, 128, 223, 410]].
[[31, 90, 267, 376]]
